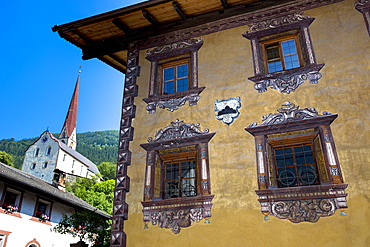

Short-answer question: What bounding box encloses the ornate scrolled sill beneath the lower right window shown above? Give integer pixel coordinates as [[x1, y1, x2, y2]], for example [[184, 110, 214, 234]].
[[256, 184, 348, 223]]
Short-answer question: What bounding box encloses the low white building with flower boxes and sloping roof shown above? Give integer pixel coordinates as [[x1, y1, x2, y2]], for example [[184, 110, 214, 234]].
[[0, 163, 110, 247]]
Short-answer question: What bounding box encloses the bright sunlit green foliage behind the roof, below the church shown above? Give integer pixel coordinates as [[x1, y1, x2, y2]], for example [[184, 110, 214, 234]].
[[66, 177, 114, 214]]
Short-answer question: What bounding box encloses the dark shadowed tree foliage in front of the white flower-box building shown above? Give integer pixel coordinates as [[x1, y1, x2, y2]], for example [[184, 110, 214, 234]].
[[52, 210, 111, 247]]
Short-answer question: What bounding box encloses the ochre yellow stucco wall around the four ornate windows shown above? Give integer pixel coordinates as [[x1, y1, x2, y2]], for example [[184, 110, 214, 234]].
[[124, 1, 370, 247]]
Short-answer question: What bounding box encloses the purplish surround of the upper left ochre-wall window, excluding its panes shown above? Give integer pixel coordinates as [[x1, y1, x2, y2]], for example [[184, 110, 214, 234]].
[[143, 38, 205, 113]]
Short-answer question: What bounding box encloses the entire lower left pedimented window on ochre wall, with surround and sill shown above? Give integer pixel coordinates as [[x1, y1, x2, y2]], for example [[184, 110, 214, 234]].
[[141, 120, 215, 234]]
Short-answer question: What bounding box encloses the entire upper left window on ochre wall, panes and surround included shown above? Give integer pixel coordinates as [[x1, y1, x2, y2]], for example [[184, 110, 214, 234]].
[[143, 39, 204, 113]]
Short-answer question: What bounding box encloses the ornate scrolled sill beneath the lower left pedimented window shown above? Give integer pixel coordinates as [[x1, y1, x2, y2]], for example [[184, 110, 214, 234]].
[[141, 195, 214, 234]]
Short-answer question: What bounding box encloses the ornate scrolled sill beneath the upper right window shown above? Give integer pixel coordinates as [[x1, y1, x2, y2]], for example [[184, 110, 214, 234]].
[[248, 64, 325, 94]]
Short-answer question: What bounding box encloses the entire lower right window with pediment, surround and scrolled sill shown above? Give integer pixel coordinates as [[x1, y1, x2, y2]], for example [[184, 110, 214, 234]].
[[246, 102, 348, 223]]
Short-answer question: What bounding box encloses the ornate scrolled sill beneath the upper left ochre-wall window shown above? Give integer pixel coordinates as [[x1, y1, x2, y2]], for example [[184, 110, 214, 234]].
[[143, 87, 205, 113]]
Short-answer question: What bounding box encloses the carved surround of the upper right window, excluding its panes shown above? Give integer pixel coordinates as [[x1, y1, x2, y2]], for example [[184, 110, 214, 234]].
[[243, 13, 325, 94]]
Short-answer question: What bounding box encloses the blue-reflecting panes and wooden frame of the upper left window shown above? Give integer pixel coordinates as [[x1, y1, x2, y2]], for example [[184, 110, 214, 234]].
[[161, 59, 190, 95]]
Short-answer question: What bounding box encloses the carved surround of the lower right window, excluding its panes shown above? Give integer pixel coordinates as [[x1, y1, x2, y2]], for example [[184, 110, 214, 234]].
[[245, 102, 348, 223]]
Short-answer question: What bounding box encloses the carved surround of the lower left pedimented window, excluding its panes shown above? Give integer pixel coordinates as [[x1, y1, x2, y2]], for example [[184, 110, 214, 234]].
[[140, 119, 216, 234]]
